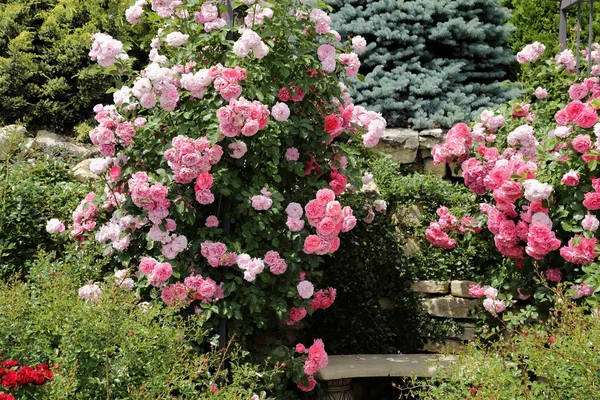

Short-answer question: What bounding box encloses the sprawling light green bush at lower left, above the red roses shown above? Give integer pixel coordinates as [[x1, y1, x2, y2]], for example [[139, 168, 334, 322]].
[[0, 249, 280, 400]]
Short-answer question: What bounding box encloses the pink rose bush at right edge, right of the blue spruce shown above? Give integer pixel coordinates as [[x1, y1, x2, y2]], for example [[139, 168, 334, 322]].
[[426, 43, 600, 315]]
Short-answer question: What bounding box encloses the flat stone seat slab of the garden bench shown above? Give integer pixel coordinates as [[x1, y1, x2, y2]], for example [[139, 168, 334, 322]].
[[315, 354, 456, 381]]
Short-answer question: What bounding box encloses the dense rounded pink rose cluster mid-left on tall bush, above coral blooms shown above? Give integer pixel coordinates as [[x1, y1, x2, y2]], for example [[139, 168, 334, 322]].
[[165, 135, 223, 184]]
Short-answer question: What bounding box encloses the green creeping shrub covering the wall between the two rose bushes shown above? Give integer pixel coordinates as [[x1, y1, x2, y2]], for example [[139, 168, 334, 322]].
[[370, 158, 502, 281]]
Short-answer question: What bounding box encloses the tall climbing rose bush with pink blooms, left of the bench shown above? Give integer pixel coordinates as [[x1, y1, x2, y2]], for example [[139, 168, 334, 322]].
[[52, 0, 386, 388]]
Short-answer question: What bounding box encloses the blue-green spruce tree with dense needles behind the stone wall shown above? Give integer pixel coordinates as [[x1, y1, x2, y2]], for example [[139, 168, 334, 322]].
[[328, 0, 518, 129]]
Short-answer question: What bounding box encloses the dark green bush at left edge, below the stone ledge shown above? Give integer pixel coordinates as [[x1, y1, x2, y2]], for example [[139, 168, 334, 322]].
[[0, 132, 89, 277]]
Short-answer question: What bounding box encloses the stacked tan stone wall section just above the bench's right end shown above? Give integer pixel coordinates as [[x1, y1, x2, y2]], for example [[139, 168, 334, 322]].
[[411, 280, 480, 352]]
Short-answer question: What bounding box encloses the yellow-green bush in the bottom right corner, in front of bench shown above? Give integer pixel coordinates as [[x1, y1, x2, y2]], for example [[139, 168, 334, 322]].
[[413, 294, 600, 400]]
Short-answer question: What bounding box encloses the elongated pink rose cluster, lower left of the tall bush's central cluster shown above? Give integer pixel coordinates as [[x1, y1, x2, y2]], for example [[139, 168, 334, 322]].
[[128, 171, 171, 224]]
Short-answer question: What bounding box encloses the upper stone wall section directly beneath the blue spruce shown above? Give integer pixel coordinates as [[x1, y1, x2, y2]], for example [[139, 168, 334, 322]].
[[374, 128, 448, 178]]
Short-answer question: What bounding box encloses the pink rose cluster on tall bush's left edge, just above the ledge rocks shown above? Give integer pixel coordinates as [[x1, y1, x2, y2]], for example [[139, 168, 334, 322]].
[[90, 104, 135, 157]]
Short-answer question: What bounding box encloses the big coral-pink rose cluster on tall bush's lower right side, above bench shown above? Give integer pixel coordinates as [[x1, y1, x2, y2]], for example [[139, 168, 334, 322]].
[[300, 189, 356, 255]]
